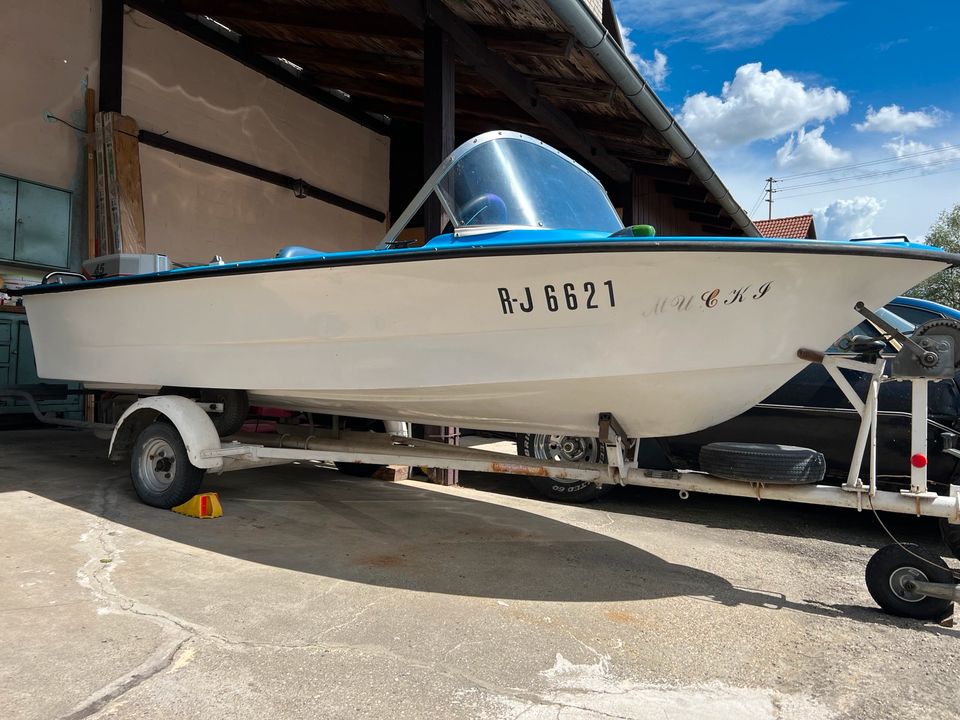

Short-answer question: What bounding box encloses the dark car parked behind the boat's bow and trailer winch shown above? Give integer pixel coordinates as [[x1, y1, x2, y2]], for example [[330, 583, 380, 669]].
[[517, 297, 960, 502]]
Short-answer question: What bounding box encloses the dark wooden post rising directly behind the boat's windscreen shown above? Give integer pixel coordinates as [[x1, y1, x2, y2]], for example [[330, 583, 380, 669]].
[[423, 22, 459, 485]]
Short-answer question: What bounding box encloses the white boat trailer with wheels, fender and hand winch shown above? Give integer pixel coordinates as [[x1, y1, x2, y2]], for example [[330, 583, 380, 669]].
[[7, 306, 960, 620]]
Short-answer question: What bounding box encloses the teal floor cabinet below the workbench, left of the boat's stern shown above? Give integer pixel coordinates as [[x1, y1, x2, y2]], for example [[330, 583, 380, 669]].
[[0, 313, 81, 418]]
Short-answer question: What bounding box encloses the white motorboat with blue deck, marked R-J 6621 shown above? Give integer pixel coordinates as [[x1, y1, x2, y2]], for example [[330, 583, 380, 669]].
[[20, 132, 960, 437]]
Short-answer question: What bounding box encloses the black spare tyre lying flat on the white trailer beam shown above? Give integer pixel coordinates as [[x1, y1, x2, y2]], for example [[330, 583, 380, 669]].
[[700, 442, 827, 485]]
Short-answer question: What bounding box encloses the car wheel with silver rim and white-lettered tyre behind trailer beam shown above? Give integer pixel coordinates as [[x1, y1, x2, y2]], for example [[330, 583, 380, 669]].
[[517, 434, 613, 503]]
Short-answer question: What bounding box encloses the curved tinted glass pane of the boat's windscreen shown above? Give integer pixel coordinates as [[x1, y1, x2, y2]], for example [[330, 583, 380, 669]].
[[437, 137, 623, 232]]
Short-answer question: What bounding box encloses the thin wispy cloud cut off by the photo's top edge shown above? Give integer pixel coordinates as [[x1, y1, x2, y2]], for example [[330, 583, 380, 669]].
[[616, 0, 842, 49]]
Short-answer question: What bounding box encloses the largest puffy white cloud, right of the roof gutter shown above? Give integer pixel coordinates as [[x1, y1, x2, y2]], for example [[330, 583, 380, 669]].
[[679, 63, 850, 149]]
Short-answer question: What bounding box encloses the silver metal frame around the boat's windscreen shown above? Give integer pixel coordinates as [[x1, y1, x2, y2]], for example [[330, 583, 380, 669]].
[[376, 130, 623, 250]]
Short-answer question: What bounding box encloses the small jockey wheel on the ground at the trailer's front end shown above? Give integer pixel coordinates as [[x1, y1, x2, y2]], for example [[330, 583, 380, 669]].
[[865, 543, 955, 620]]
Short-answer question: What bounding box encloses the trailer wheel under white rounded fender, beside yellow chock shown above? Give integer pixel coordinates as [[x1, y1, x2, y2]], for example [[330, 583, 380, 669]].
[[130, 422, 204, 510]]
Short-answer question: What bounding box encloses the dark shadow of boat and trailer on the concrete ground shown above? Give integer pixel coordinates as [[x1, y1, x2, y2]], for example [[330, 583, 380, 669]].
[[0, 430, 956, 629]]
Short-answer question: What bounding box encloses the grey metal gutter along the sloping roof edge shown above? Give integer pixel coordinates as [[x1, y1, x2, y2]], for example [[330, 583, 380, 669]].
[[546, 0, 760, 237]]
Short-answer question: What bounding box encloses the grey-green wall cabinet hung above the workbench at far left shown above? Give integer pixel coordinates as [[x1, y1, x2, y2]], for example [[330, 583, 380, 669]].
[[0, 176, 71, 267]]
